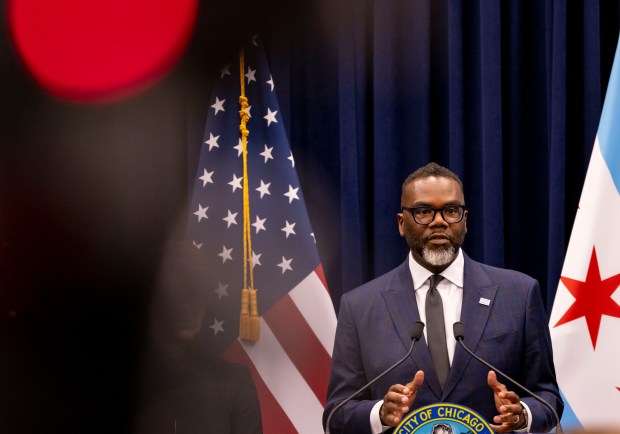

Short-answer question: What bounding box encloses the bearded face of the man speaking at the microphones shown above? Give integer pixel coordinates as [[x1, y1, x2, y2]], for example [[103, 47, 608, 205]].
[[397, 177, 467, 272]]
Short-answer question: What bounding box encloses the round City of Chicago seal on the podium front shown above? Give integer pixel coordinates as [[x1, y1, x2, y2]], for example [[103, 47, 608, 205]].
[[394, 402, 494, 434]]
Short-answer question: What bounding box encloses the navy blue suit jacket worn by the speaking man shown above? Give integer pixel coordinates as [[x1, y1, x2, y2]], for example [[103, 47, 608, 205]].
[[323, 255, 563, 434]]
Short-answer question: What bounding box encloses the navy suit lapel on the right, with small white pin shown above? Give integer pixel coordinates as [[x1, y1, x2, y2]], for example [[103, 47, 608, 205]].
[[444, 255, 497, 397]]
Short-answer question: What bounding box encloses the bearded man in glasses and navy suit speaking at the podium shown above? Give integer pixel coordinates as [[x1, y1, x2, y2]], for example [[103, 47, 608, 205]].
[[324, 163, 563, 434]]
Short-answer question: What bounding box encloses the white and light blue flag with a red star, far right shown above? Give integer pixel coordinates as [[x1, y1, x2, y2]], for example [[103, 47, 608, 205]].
[[549, 35, 620, 428]]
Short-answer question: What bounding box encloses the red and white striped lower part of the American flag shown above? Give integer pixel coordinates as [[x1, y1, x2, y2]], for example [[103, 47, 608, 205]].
[[225, 266, 336, 434]]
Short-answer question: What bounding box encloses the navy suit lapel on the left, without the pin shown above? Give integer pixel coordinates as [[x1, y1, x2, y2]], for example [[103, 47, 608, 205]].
[[382, 261, 449, 400]]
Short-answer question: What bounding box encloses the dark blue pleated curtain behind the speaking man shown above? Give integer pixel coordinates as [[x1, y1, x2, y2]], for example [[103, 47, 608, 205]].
[[228, 0, 620, 318]]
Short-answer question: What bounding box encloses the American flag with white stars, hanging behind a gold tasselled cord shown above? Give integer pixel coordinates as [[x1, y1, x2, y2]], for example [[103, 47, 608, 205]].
[[188, 37, 336, 434]]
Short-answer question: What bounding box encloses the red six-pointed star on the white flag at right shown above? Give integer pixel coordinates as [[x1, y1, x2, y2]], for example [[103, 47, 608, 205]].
[[554, 248, 620, 349]]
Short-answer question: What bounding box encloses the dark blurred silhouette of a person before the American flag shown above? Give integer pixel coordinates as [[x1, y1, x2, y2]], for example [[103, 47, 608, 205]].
[[132, 242, 263, 434]]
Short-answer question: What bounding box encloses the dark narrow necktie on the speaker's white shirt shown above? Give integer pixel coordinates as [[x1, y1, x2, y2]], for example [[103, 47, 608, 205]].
[[426, 274, 450, 390]]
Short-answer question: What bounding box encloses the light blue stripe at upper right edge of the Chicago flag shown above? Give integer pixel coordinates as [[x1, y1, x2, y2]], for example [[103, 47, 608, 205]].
[[598, 34, 620, 194]]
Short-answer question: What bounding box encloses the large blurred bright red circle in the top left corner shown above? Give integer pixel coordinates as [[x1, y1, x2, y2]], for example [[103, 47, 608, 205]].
[[8, 0, 198, 102]]
